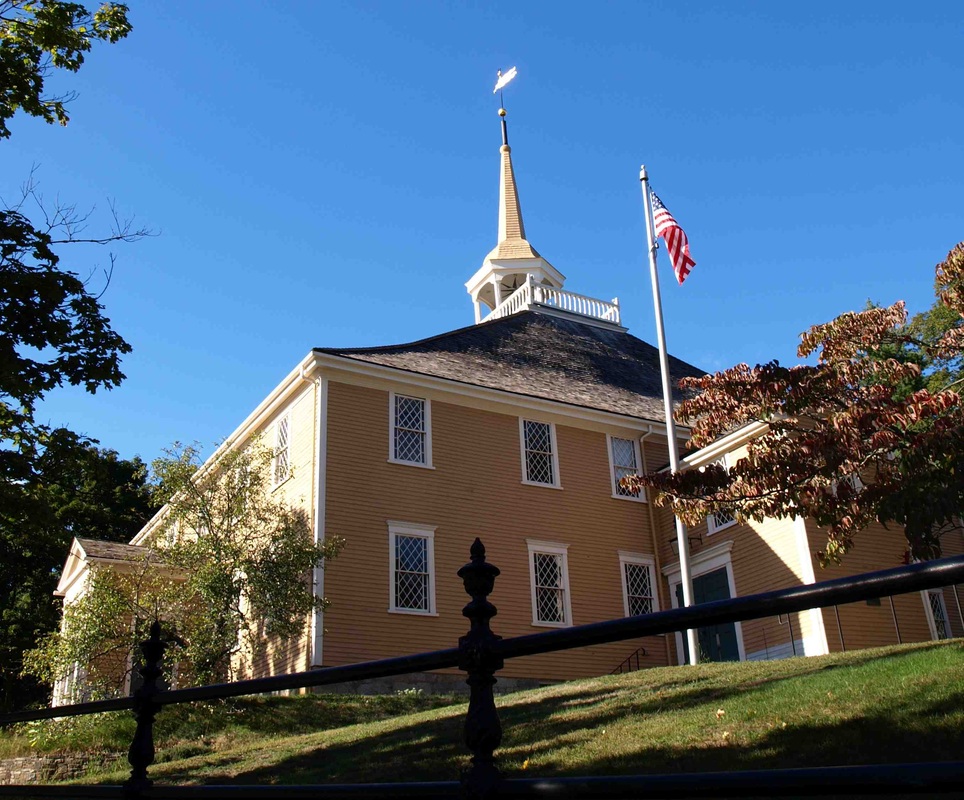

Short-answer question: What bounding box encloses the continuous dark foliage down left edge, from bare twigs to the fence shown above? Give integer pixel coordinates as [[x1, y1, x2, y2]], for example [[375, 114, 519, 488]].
[[0, 184, 150, 707]]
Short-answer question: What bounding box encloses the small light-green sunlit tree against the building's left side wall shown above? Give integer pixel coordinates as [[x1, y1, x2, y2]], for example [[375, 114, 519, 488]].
[[29, 443, 342, 692]]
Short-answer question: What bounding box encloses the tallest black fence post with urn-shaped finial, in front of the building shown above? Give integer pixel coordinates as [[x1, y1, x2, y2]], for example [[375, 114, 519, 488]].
[[458, 538, 504, 800]]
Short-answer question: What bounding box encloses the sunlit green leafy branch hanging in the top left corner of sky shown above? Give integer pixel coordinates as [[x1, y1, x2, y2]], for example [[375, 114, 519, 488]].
[[0, 0, 131, 139]]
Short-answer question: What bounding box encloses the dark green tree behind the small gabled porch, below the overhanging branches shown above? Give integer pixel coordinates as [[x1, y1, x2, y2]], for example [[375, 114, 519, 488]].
[[0, 428, 155, 710]]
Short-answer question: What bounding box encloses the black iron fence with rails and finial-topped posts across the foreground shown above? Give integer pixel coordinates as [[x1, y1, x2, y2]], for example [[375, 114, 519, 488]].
[[0, 539, 964, 800]]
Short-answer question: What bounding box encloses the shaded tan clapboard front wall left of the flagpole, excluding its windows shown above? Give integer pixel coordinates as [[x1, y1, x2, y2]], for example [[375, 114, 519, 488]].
[[324, 381, 665, 680]]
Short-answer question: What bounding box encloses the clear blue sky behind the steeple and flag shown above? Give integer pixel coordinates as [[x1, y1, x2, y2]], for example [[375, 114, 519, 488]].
[[0, 0, 964, 460]]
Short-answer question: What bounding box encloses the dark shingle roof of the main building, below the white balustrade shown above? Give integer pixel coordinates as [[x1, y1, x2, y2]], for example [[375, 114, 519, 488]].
[[315, 310, 705, 421]]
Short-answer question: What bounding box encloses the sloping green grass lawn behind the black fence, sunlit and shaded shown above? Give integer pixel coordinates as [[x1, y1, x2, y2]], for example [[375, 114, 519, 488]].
[[7, 640, 964, 784]]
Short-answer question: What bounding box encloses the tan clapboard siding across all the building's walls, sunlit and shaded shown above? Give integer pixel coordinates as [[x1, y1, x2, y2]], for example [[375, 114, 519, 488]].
[[173, 368, 964, 680]]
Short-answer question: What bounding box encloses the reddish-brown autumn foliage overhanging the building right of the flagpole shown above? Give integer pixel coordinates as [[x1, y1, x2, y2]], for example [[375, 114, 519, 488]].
[[627, 243, 964, 562]]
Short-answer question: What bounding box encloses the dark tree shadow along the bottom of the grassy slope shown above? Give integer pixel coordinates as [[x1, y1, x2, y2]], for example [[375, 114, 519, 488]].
[[163, 692, 964, 784]]
